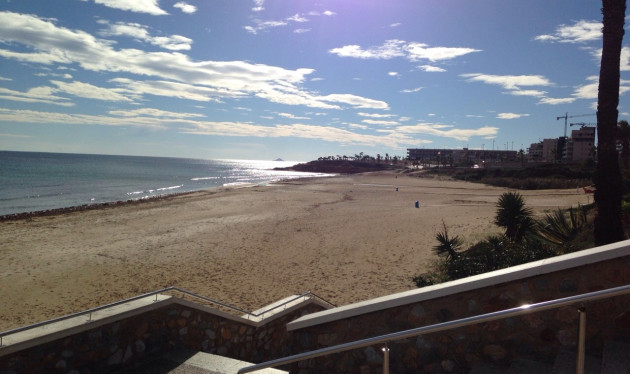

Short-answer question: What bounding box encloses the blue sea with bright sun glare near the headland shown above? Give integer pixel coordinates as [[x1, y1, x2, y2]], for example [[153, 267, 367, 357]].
[[0, 151, 328, 216]]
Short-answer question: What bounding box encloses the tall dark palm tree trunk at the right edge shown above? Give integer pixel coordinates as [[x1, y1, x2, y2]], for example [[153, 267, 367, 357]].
[[595, 0, 626, 245]]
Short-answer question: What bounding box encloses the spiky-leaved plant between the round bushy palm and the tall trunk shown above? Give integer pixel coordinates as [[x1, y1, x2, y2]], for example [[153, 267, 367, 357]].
[[536, 205, 586, 245]]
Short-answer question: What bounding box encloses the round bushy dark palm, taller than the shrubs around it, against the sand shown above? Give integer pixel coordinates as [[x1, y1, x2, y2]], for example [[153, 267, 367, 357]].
[[494, 192, 534, 242]]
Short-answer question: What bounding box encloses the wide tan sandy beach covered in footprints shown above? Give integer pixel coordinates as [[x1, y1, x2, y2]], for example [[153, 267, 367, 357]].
[[0, 172, 592, 331]]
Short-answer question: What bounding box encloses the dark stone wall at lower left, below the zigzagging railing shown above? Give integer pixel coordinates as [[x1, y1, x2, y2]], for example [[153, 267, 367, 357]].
[[0, 302, 324, 374]]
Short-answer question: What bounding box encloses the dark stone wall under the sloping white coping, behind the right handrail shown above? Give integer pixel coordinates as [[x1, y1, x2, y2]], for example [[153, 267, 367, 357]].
[[291, 256, 630, 374]]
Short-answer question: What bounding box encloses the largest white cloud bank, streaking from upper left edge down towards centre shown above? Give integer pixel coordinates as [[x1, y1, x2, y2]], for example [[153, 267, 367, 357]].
[[0, 12, 388, 109]]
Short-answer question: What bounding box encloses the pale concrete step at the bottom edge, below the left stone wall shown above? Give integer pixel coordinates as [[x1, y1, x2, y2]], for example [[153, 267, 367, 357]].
[[120, 349, 288, 374]]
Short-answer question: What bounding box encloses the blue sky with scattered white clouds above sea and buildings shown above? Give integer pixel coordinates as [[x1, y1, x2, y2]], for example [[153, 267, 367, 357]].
[[0, 0, 630, 161]]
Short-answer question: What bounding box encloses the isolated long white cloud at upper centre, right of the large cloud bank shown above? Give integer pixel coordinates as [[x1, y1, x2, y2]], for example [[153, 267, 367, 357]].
[[328, 39, 481, 62]]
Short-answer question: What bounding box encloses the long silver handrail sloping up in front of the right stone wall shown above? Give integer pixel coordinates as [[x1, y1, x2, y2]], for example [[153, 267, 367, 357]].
[[238, 285, 630, 374]]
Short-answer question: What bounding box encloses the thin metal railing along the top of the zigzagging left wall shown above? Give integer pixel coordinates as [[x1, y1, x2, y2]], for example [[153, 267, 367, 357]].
[[0, 287, 336, 348]]
